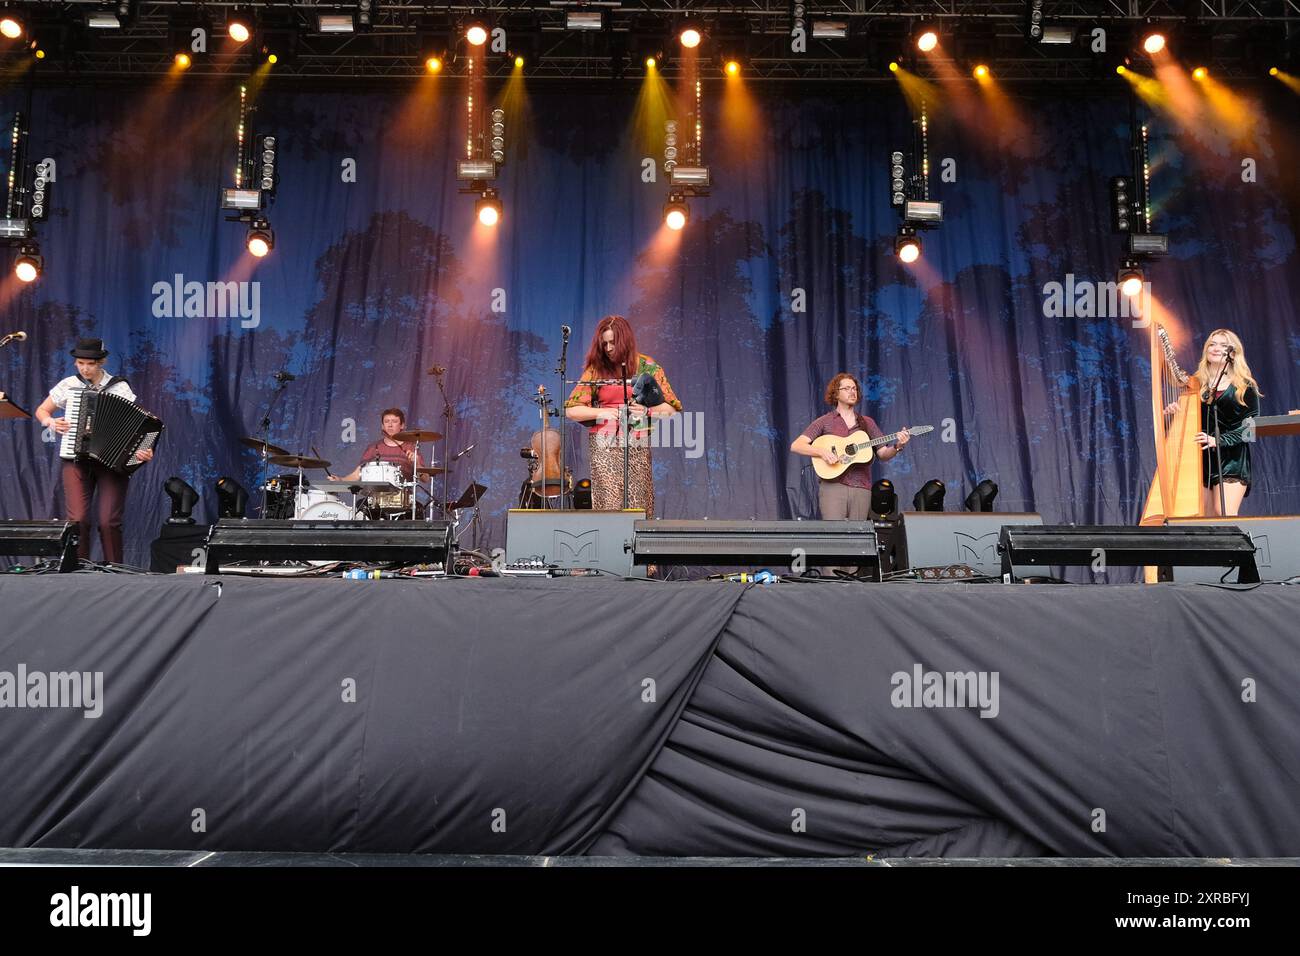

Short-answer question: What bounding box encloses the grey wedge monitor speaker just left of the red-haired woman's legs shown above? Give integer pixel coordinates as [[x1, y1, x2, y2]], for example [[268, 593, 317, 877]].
[[506, 509, 646, 578]]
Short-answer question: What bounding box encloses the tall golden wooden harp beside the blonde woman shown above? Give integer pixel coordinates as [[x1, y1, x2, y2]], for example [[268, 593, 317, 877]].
[[1139, 323, 1201, 535]]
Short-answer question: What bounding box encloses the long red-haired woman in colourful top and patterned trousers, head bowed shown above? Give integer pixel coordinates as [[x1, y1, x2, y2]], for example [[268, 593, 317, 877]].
[[564, 315, 681, 518]]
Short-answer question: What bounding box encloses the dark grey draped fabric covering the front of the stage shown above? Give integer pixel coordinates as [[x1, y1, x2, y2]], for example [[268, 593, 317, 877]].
[[0, 574, 1300, 861]]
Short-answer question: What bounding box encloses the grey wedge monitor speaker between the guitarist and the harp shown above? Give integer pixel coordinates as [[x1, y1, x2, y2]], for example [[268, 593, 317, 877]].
[[900, 511, 1043, 578]]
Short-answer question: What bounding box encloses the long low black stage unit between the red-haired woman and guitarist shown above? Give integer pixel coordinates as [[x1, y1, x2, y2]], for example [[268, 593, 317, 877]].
[[631, 519, 879, 578]]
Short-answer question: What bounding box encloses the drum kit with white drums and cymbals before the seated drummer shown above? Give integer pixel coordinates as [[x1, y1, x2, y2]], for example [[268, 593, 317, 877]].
[[239, 429, 447, 522]]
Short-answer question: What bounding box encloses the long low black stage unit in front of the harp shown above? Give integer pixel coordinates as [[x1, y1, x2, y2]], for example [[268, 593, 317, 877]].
[[998, 524, 1260, 584]]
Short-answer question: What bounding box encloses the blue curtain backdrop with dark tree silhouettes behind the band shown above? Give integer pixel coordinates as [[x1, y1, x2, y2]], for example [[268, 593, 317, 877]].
[[0, 78, 1300, 564]]
